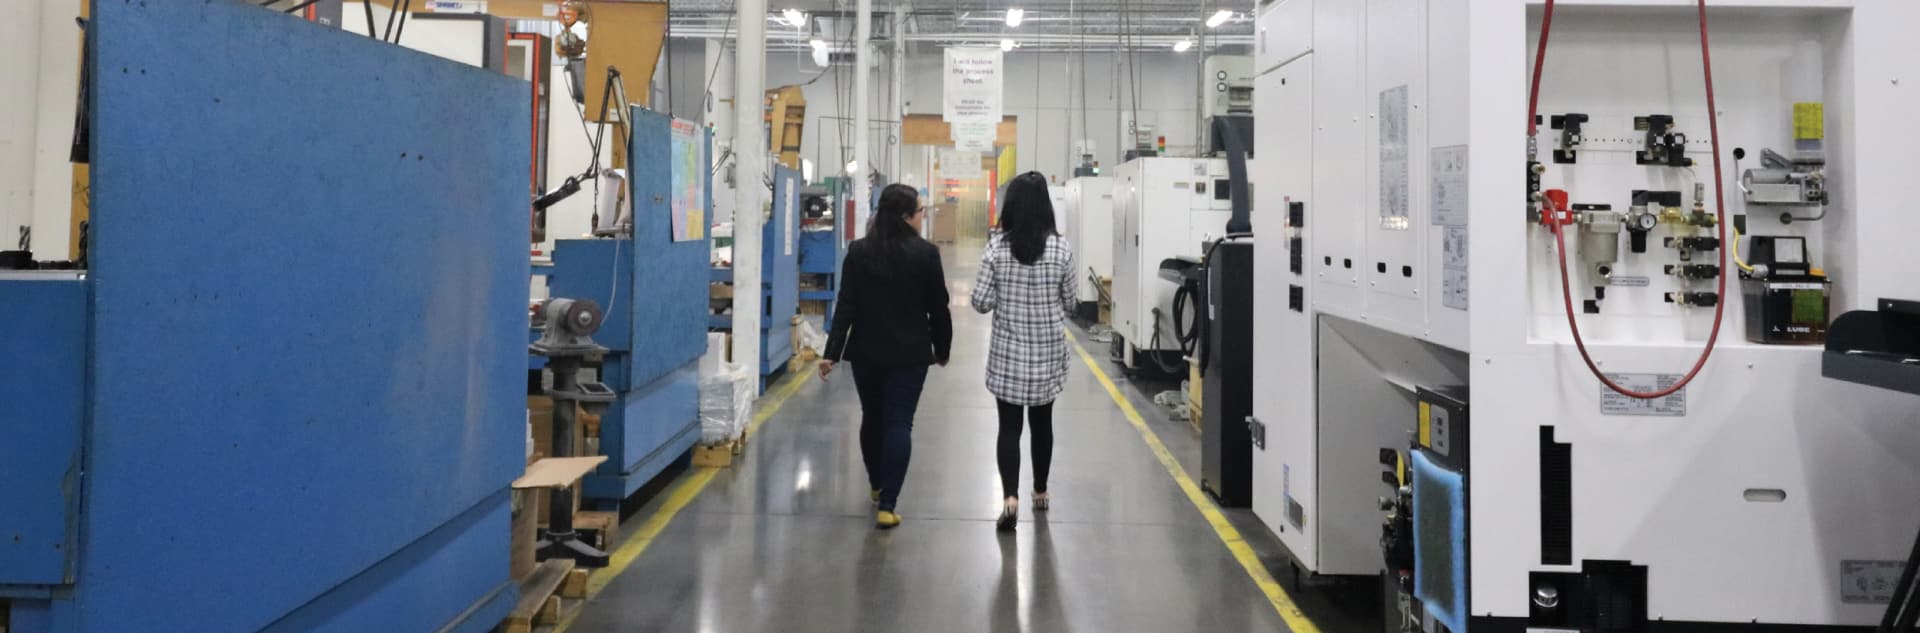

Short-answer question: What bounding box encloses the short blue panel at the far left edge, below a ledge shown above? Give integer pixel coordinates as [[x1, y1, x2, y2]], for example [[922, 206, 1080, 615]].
[[0, 278, 86, 595]]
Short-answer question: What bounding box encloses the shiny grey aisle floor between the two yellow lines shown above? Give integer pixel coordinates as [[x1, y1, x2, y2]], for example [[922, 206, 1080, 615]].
[[564, 246, 1288, 633]]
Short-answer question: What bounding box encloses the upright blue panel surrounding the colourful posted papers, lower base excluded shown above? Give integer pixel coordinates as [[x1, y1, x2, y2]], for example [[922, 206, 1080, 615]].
[[626, 107, 712, 389]]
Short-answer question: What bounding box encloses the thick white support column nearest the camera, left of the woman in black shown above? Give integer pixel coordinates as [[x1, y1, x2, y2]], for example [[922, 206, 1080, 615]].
[[733, 0, 772, 372]]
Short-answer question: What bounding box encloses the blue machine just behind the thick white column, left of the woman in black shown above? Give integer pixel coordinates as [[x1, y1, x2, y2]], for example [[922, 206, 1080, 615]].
[[708, 165, 801, 393]]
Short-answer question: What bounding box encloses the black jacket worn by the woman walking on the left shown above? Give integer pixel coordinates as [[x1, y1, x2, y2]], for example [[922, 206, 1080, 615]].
[[826, 238, 954, 366]]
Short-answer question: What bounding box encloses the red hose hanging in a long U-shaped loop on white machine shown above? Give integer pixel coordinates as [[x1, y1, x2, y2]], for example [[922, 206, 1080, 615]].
[[1526, 0, 1728, 399]]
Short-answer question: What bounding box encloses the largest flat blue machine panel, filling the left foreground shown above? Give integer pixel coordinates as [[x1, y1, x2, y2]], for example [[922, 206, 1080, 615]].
[[75, 0, 530, 631]]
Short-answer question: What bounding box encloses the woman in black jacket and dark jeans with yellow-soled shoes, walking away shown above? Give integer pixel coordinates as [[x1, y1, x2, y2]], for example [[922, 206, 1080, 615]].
[[820, 184, 954, 529]]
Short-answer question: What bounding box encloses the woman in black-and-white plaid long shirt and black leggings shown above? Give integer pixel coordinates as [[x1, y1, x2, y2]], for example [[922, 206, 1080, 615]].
[[972, 171, 1075, 529]]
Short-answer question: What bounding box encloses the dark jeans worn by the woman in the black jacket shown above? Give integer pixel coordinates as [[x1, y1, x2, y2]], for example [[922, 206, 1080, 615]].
[[852, 363, 927, 512]]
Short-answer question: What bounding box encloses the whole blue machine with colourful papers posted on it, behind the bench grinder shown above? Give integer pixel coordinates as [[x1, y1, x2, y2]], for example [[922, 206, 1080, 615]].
[[547, 107, 712, 508]]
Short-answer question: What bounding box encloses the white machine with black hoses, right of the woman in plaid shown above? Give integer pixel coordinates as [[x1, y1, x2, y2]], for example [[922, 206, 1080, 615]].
[[1112, 157, 1254, 368]]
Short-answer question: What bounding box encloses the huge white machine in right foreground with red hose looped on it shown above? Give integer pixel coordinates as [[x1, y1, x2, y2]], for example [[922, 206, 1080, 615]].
[[1244, 0, 1920, 631]]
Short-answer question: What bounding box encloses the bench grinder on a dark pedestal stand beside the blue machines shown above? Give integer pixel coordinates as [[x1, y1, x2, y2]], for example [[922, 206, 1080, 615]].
[[528, 299, 614, 568]]
